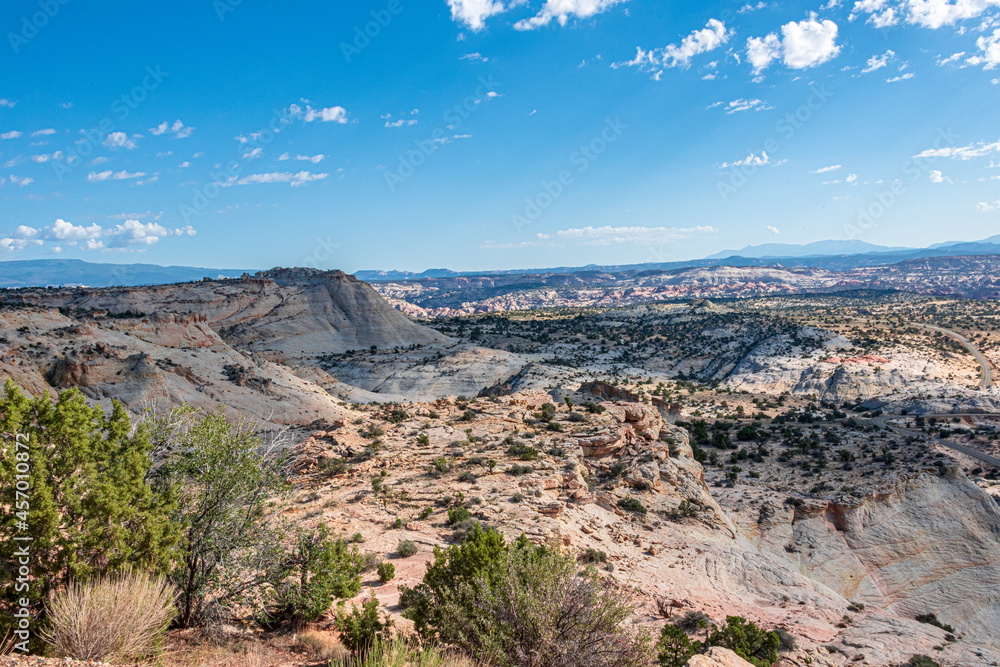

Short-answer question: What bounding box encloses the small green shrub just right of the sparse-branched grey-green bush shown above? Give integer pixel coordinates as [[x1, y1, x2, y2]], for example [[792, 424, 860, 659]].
[[258, 523, 364, 629]]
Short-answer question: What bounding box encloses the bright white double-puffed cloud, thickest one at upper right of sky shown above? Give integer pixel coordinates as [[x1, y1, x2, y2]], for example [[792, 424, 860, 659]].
[[746, 14, 840, 73]]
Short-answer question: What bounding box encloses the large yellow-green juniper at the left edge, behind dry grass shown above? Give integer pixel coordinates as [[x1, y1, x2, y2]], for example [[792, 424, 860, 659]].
[[0, 380, 180, 648]]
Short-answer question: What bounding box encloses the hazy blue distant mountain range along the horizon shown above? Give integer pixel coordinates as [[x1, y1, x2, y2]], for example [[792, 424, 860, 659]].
[[0, 234, 1000, 288]]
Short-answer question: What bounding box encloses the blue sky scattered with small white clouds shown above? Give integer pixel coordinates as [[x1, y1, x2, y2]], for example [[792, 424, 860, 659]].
[[0, 0, 1000, 271]]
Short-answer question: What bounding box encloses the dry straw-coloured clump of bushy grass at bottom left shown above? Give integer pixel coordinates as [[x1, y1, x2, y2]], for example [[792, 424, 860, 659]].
[[42, 572, 177, 664]]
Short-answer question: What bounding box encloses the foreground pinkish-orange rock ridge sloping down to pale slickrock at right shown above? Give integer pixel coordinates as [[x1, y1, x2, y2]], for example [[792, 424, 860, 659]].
[[286, 392, 1000, 665]]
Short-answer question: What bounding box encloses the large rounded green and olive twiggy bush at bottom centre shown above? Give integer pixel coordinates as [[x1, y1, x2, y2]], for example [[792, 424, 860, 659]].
[[400, 528, 650, 667]]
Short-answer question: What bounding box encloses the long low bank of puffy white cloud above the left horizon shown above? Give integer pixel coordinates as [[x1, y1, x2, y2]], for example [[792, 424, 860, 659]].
[[0, 218, 197, 251]]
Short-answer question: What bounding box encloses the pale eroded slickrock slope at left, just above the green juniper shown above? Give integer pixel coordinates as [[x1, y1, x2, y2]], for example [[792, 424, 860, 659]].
[[0, 307, 345, 425]]
